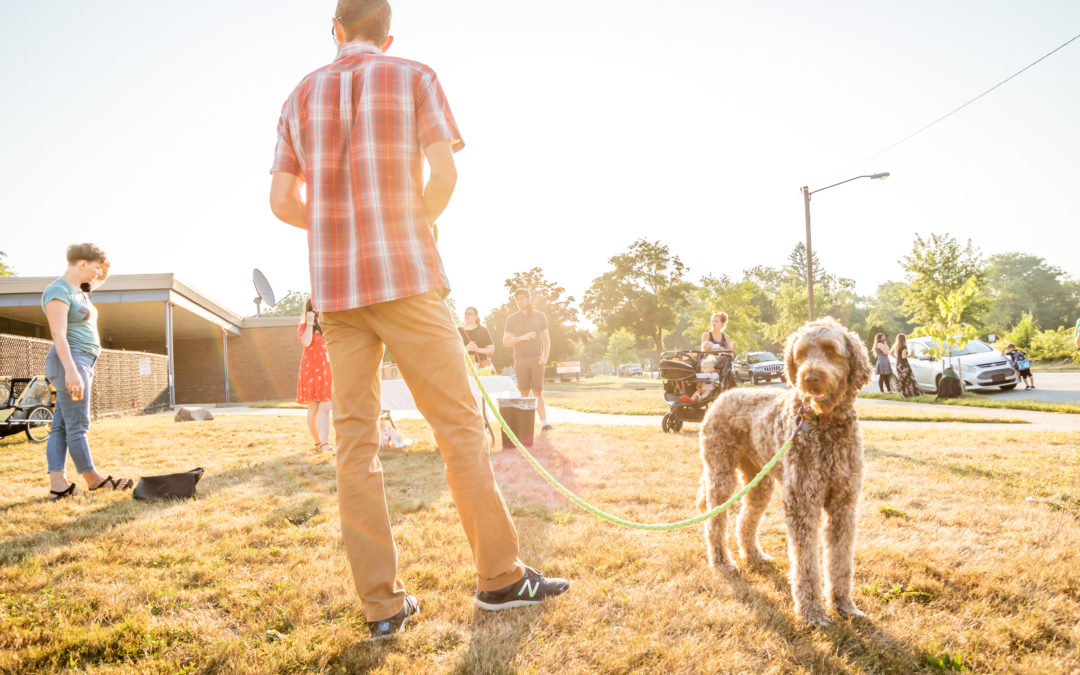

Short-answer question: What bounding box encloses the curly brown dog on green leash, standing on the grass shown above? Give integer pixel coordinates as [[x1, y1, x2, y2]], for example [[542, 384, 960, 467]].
[[698, 319, 870, 626]]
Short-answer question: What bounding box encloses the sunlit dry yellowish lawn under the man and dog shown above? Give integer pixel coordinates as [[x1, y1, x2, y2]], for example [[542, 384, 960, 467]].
[[0, 416, 1080, 673]]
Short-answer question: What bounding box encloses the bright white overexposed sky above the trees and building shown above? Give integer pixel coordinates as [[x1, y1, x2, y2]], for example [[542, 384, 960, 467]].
[[0, 0, 1080, 314]]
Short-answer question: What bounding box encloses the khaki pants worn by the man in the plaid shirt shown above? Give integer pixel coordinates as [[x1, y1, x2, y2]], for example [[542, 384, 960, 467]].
[[320, 291, 525, 621]]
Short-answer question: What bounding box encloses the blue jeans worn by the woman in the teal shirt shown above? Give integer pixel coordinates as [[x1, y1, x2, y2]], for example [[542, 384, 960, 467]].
[[45, 347, 97, 474]]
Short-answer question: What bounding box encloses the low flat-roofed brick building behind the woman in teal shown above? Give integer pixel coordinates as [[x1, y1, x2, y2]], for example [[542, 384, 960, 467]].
[[0, 274, 301, 406]]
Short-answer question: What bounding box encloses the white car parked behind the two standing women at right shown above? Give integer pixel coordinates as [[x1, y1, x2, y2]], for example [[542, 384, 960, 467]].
[[892, 337, 1020, 393]]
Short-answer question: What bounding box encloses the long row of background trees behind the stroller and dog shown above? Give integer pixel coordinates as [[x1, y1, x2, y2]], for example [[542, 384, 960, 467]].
[[484, 233, 1080, 368]]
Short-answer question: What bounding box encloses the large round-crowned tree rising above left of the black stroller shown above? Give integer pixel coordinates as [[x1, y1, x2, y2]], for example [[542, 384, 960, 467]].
[[582, 239, 693, 362]]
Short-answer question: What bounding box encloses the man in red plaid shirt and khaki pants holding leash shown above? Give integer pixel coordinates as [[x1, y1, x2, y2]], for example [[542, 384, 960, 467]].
[[270, 0, 569, 639]]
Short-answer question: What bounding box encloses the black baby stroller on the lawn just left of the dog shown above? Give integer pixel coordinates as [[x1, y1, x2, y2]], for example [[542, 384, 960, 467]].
[[660, 349, 735, 432]]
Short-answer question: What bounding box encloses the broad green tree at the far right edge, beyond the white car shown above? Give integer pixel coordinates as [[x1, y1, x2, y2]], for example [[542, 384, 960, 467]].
[[984, 253, 1080, 333]]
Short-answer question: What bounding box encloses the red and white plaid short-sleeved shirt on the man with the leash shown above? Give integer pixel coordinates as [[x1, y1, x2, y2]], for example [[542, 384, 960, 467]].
[[271, 42, 464, 312]]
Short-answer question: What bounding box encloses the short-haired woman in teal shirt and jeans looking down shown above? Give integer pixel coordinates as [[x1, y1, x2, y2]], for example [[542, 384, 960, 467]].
[[41, 244, 133, 499]]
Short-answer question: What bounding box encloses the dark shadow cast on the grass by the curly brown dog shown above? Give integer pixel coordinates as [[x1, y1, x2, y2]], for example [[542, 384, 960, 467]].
[[724, 563, 921, 673]]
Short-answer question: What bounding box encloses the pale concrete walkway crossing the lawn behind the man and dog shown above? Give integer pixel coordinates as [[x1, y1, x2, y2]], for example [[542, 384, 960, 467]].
[[185, 400, 1080, 433]]
